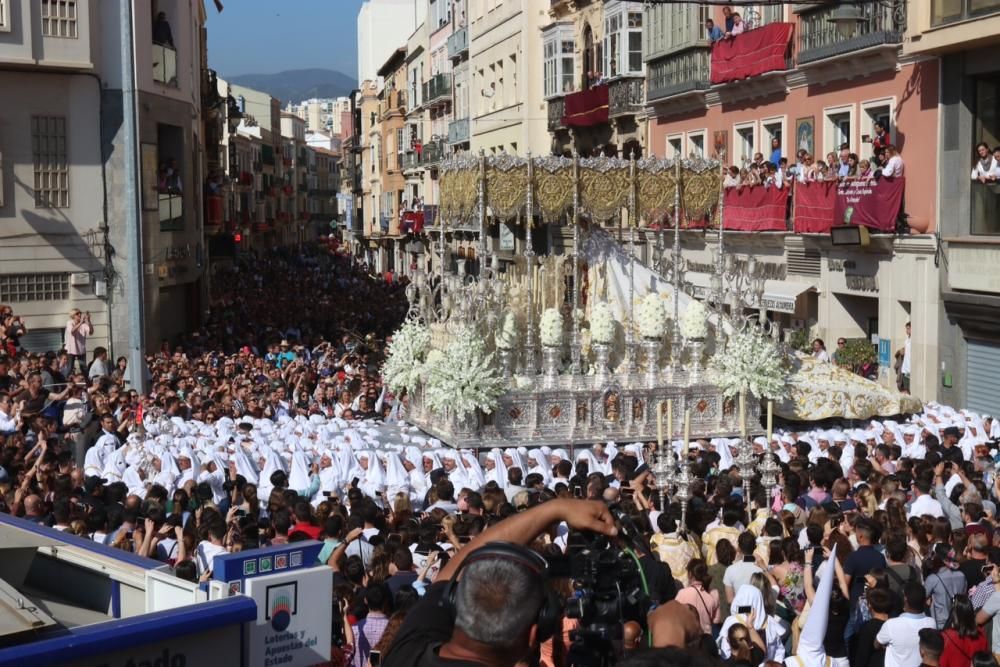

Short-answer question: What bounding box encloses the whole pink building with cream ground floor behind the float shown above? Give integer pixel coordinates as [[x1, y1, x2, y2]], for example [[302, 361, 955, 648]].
[[643, 0, 944, 400]]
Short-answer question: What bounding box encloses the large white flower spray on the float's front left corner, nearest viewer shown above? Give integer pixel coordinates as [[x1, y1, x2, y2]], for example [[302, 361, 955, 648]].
[[424, 330, 506, 419]]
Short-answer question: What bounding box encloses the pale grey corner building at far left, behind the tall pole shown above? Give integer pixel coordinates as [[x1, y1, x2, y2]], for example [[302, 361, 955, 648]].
[[0, 0, 209, 353]]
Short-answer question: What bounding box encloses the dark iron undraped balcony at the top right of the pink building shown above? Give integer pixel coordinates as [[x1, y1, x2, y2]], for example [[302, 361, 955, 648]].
[[798, 0, 906, 65]]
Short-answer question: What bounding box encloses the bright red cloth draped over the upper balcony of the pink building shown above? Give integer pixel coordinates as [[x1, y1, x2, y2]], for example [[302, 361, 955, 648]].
[[712, 23, 794, 85]]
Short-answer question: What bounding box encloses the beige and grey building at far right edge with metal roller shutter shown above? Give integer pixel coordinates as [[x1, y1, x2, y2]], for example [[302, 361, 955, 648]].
[[904, 0, 1000, 414]]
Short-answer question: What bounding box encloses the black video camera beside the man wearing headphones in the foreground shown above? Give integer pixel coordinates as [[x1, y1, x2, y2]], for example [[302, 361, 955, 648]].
[[549, 505, 649, 667]]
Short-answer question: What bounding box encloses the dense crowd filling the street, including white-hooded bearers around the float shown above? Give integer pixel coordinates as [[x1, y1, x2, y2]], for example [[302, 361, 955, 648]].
[[0, 251, 1000, 667]]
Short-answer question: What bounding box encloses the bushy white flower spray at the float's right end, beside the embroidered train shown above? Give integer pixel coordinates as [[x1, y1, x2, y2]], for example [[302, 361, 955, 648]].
[[709, 329, 788, 401]]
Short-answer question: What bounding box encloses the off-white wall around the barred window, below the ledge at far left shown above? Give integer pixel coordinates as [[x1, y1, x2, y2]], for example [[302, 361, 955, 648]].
[[0, 72, 108, 350]]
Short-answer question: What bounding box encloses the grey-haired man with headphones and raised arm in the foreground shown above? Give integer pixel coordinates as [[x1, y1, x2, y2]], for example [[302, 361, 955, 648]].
[[382, 499, 618, 667]]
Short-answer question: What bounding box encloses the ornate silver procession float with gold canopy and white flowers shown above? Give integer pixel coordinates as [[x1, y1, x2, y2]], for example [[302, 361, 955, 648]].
[[383, 155, 920, 454]]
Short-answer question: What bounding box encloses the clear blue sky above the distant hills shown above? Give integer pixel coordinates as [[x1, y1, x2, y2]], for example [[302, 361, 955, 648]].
[[205, 0, 362, 78]]
